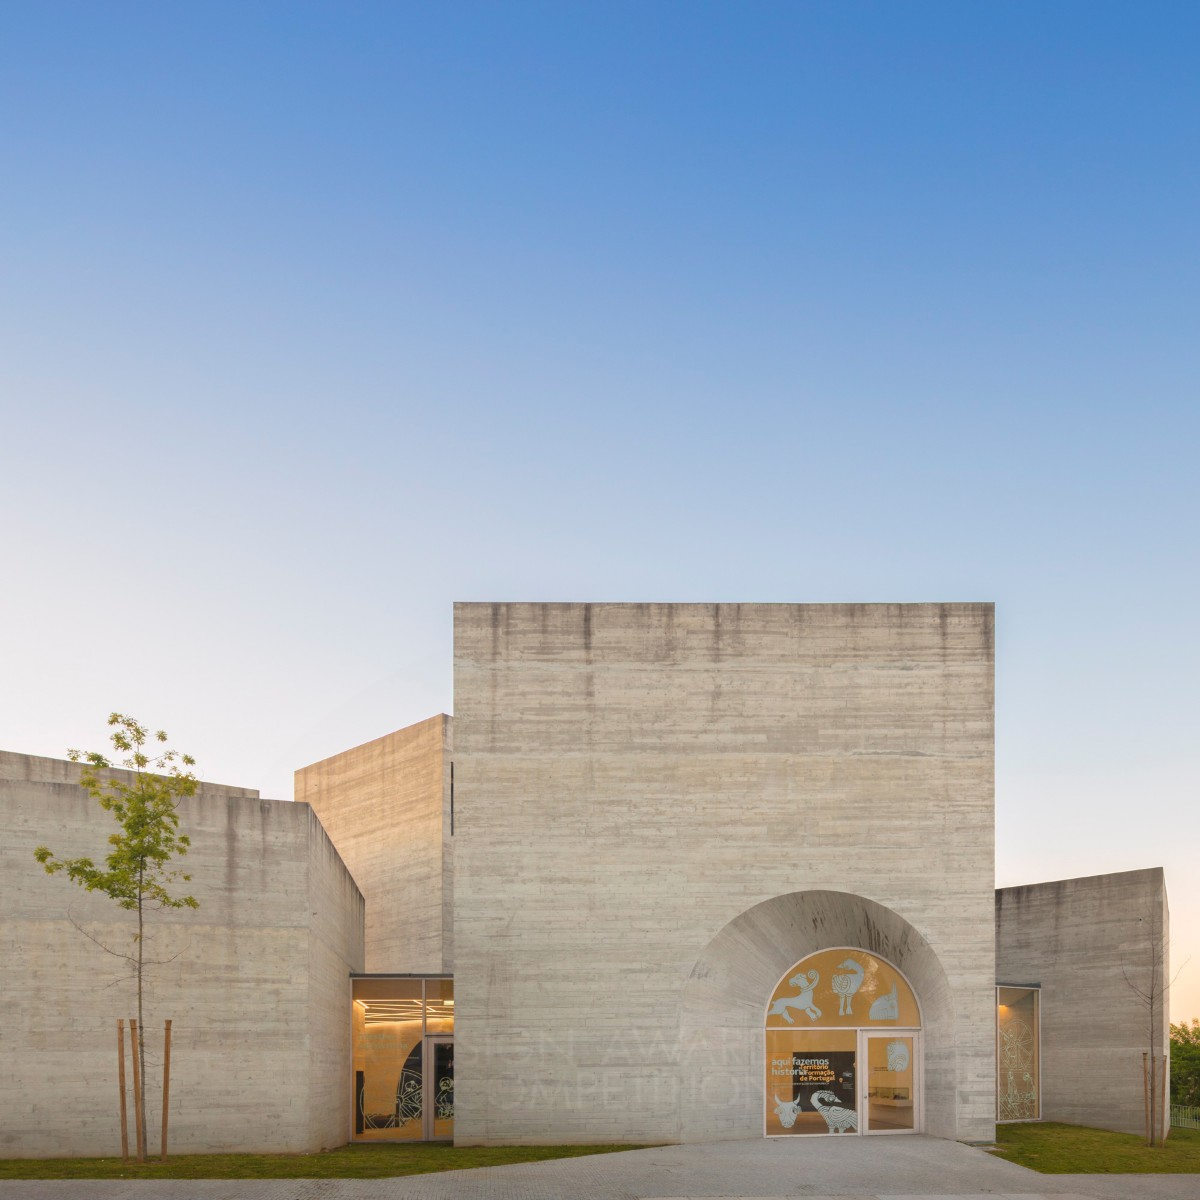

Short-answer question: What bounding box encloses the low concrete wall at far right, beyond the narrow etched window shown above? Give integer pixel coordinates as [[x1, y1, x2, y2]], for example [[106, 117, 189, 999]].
[[996, 866, 1170, 1133]]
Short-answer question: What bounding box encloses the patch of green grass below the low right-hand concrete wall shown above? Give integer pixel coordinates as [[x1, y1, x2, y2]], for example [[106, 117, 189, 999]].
[[994, 1121, 1200, 1175]]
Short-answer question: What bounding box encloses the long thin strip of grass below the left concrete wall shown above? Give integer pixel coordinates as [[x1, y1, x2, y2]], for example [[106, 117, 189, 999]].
[[0, 1142, 644, 1180]]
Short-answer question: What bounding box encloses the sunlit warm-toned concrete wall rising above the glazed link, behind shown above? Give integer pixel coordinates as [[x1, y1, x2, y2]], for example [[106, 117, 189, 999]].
[[295, 715, 454, 974]]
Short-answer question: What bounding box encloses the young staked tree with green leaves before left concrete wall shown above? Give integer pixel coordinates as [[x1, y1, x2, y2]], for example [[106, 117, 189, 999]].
[[35, 713, 199, 1148]]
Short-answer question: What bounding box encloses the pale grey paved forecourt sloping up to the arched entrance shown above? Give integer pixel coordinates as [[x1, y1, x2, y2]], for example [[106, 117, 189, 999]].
[[0, 1136, 1200, 1200]]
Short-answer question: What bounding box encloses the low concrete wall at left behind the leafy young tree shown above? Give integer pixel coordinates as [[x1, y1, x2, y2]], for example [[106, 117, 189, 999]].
[[0, 752, 364, 1157]]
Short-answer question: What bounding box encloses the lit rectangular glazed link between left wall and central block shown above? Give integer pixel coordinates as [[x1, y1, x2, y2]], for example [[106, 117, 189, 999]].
[[352, 978, 454, 1141]]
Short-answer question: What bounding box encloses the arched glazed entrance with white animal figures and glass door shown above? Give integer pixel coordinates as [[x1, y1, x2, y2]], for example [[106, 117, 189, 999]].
[[763, 946, 922, 1138]]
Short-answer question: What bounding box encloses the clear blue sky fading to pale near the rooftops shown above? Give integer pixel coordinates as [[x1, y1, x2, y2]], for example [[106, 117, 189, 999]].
[[0, 0, 1200, 1020]]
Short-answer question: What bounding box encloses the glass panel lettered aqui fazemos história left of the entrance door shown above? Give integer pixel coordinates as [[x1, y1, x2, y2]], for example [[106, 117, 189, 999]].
[[767, 1030, 858, 1136]]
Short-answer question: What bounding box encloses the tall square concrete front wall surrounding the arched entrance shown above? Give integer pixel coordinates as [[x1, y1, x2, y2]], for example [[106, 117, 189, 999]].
[[454, 604, 995, 1144]]
